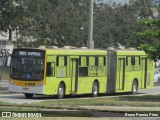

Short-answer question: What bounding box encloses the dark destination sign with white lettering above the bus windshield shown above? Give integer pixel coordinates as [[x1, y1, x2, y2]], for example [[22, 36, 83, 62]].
[[15, 51, 43, 57]]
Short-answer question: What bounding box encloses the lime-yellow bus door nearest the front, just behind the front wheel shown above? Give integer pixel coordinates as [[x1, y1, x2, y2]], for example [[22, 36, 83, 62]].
[[71, 58, 78, 92]]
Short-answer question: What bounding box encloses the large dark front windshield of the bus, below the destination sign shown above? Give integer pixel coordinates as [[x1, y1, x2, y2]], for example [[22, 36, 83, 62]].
[[10, 57, 44, 80]]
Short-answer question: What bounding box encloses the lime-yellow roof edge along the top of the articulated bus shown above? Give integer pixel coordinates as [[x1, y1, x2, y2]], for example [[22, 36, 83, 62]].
[[14, 48, 146, 55]]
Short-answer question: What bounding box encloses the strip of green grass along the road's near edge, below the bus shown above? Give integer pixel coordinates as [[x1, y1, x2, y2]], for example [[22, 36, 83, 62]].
[[23, 95, 160, 108]]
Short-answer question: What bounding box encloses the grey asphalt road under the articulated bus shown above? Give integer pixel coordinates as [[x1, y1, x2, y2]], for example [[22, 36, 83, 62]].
[[0, 86, 160, 104]]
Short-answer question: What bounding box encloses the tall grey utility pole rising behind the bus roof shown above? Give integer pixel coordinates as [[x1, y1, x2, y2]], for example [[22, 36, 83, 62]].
[[87, 0, 94, 49]]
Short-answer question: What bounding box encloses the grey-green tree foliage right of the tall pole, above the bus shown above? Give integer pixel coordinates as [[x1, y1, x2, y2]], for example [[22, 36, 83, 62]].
[[94, 0, 151, 48]]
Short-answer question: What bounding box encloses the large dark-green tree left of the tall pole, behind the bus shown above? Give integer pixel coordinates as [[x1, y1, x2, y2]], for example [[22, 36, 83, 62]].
[[16, 0, 88, 47]]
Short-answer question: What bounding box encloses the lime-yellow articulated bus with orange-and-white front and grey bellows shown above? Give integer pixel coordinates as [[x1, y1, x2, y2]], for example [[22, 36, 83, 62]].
[[9, 48, 154, 99]]
